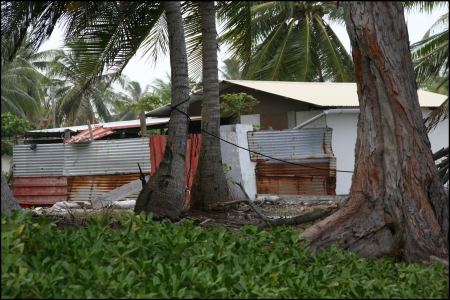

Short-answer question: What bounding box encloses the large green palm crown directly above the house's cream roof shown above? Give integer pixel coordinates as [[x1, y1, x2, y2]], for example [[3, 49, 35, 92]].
[[219, 1, 353, 82]]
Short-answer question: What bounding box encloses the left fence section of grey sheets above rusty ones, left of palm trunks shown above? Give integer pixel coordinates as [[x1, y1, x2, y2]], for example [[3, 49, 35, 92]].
[[13, 138, 150, 206]]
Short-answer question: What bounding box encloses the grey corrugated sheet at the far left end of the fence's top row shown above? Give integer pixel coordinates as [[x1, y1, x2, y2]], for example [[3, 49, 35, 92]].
[[13, 144, 64, 177]]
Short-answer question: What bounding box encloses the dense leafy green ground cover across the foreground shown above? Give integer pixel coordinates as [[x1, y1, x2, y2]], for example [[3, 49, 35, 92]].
[[1, 212, 448, 299]]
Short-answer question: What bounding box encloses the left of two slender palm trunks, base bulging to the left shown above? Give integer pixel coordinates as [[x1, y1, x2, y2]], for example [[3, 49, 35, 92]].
[[135, 1, 189, 219]]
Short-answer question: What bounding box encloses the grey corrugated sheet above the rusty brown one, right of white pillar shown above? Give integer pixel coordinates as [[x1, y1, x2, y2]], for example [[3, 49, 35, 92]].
[[247, 128, 333, 163]]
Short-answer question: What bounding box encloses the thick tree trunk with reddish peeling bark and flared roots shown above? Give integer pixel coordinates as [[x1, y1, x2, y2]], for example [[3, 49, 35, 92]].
[[303, 1, 448, 262]]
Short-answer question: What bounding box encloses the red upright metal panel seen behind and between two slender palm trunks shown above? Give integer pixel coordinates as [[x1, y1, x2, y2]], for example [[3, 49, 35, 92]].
[[149, 134, 202, 207]]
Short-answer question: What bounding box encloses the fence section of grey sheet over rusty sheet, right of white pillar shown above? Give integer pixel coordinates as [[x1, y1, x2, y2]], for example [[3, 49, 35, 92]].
[[248, 128, 336, 195]]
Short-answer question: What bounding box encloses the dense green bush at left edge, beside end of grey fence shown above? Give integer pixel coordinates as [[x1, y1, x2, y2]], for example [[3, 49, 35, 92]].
[[1, 112, 34, 155]]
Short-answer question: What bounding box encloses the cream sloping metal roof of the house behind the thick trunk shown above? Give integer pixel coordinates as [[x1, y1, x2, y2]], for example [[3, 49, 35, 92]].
[[224, 80, 447, 107]]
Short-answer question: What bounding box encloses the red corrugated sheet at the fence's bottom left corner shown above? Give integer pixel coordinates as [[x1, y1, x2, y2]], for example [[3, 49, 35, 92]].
[[12, 176, 68, 206]]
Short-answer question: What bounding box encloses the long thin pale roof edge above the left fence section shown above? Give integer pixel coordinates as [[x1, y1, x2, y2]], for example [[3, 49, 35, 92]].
[[28, 117, 201, 132]]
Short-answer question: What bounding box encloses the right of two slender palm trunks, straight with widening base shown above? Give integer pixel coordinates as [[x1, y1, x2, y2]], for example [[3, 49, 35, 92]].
[[191, 1, 230, 209]]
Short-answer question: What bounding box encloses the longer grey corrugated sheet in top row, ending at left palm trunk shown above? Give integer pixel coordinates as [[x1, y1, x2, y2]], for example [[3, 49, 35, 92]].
[[63, 137, 150, 176]]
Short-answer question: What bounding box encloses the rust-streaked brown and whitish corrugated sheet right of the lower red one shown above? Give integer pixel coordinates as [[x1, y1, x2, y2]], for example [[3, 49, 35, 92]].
[[68, 173, 148, 201]]
